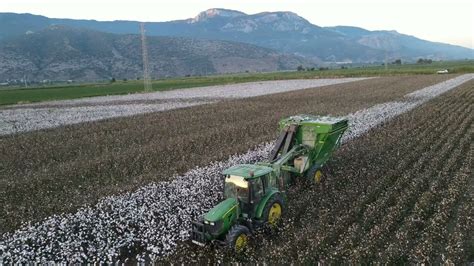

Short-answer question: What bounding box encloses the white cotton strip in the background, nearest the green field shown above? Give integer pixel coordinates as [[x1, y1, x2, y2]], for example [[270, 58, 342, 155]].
[[0, 78, 366, 135]]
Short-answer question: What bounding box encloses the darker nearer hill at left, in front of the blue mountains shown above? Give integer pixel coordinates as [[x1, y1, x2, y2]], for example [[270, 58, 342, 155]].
[[0, 25, 313, 81]]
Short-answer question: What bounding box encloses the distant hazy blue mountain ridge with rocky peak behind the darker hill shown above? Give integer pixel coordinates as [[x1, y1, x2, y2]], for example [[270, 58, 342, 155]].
[[0, 8, 474, 63]]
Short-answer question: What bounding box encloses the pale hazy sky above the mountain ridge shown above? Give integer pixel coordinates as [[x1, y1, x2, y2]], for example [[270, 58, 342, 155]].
[[0, 0, 474, 48]]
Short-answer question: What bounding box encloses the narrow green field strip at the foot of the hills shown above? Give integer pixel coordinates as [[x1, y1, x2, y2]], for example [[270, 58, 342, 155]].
[[0, 60, 474, 105]]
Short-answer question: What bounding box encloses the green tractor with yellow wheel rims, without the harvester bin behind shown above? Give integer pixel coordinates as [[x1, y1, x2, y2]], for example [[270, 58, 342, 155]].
[[191, 164, 283, 247]]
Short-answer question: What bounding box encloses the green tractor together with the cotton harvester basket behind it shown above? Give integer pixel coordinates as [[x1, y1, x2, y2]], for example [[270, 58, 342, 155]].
[[191, 115, 348, 252]]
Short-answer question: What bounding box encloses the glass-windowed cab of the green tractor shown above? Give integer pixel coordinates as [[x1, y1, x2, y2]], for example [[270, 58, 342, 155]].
[[223, 164, 275, 218]]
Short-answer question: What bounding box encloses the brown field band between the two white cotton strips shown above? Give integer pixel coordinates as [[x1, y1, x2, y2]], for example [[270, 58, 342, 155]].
[[0, 76, 453, 232]]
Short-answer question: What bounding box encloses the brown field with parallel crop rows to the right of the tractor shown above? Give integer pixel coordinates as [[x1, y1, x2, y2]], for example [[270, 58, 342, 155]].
[[164, 78, 474, 264]]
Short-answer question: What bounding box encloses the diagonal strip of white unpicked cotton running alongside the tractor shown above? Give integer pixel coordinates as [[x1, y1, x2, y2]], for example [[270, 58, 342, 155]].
[[0, 75, 472, 262]]
